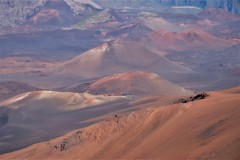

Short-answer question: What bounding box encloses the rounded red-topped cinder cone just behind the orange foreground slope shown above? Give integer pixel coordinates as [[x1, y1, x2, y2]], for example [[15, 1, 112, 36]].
[[87, 71, 192, 96]]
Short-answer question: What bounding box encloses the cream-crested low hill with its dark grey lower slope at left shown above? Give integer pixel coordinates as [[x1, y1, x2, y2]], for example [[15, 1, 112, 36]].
[[0, 91, 129, 154]]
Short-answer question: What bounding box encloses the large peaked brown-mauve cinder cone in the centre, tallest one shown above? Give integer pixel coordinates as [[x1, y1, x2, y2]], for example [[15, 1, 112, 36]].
[[48, 39, 191, 79]]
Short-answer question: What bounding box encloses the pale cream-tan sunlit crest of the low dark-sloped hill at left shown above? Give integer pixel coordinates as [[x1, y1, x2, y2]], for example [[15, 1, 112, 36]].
[[0, 91, 124, 110]]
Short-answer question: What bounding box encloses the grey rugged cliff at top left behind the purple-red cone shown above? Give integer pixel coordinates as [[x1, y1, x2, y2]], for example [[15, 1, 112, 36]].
[[0, 0, 101, 27]]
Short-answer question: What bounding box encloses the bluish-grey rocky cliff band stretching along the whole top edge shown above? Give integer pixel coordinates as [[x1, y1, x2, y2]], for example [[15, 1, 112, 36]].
[[0, 0, 240, 27]]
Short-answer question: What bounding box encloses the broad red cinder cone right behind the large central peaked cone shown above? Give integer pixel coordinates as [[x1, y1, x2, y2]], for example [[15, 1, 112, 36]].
[[150, 30, 234, 51]]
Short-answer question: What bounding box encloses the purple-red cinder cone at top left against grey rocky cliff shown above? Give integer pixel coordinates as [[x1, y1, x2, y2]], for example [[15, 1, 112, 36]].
[[27, 0, 101, 26]]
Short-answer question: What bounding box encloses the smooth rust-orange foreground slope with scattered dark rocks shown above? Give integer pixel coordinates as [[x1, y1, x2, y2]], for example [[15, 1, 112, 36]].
[[0, 88, 240, 159]]
